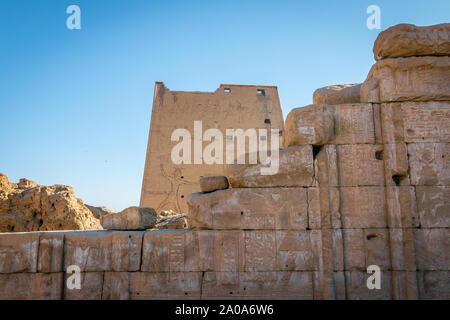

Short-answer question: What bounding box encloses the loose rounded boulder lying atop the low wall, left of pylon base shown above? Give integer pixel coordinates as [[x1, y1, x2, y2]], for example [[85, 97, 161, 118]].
[[100, 207, 158, 230]]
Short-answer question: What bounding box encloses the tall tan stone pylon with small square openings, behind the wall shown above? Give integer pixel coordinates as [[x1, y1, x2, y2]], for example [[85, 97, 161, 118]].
[[140, 82, 284, 212]]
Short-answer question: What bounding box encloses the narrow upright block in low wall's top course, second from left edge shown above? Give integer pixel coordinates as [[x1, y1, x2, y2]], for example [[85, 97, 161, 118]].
[[37, 232, 64, 273]]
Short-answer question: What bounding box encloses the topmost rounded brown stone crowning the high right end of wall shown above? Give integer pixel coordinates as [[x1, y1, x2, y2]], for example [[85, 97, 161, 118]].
[[373, 23, 450, 60]]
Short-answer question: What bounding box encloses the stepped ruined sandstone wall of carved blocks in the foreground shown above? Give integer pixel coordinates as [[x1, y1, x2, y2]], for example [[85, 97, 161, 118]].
[[0, 24, 450, 299]]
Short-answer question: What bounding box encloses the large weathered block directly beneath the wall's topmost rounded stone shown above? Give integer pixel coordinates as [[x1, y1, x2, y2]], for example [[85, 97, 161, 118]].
[[361, 56, 450, 103]]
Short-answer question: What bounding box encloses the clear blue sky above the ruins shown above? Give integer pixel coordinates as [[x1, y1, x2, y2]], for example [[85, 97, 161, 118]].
[[0, 0, 450, 210]]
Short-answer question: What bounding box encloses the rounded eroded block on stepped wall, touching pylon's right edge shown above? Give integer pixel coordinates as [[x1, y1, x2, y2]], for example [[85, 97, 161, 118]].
[[283, 105, 334, 147]]
